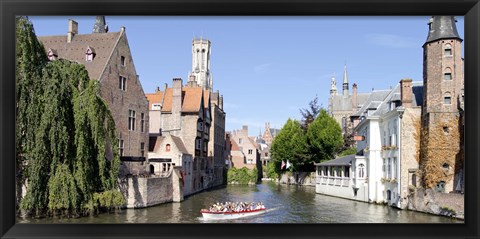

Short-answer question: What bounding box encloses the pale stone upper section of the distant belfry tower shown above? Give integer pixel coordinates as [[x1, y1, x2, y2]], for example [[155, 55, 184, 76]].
[[189, 39, 213, 91]]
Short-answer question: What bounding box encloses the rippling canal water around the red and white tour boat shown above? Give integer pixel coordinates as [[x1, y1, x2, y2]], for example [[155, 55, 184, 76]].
[[17, 181, 463, 223]]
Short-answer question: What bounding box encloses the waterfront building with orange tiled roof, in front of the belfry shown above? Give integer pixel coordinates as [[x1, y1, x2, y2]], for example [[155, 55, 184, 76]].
[[147, 78, 214, 193]]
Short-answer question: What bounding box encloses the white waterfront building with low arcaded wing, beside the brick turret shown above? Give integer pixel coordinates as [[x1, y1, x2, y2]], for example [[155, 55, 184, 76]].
[[316, 79, 423, 208]]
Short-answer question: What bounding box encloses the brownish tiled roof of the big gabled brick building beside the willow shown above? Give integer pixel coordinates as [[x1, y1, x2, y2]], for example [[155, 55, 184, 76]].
[[38, 32, 121, 80]]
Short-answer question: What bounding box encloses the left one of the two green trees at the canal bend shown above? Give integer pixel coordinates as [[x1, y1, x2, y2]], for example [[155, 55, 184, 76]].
[[271, 119, 307, 173]]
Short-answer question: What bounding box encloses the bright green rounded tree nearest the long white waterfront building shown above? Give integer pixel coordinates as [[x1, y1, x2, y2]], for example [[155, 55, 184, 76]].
[[306, 109, 343, 163]]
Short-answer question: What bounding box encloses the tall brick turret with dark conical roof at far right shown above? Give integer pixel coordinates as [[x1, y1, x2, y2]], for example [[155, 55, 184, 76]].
[[420, 16, 464, 192]]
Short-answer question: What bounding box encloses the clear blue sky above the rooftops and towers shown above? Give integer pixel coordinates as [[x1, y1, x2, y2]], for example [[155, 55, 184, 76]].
[[30, 16, 464, 136]]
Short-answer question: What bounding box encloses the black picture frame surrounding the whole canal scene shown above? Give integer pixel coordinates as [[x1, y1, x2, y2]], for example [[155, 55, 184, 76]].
[[0, 0, 480, 238]]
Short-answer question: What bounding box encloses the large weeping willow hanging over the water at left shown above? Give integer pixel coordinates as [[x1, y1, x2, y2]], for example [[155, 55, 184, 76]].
[[17, 15, 124, 216]]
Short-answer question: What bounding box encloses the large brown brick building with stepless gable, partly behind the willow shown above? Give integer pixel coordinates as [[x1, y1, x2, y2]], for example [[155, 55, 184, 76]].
[[38, 16, 149, 176]]
